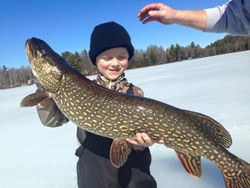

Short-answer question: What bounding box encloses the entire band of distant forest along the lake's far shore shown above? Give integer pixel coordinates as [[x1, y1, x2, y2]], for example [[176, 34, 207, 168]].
[[0, 35, 250, 89]]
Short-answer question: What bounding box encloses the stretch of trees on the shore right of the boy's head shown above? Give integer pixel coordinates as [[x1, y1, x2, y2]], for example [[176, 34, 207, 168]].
[[129, 35, 250, 68]]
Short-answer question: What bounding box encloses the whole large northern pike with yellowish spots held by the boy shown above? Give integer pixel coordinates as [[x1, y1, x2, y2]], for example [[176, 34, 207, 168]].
[[21, 38, 250, 188]]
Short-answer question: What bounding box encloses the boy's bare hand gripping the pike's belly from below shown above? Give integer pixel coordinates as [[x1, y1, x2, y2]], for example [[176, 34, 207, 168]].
[[126, 133, 164, 147]]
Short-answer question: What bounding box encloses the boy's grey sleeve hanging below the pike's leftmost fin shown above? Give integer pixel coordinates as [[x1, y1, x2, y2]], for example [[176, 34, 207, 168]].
[[36, 83, 69, 127]]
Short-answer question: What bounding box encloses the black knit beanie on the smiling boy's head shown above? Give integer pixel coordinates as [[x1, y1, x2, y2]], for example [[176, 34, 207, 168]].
[[89, 22, 134, 65]]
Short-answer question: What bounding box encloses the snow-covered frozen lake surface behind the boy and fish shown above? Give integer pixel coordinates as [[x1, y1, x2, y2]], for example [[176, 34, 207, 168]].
[[0, 51, 250, 188]]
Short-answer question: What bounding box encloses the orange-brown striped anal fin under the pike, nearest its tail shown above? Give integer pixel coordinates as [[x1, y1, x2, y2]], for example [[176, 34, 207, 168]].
[[175, 151, 202, 178]]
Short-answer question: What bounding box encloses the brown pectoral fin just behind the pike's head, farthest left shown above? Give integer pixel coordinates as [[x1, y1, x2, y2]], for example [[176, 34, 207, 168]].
[[20, 90, 48, 107]]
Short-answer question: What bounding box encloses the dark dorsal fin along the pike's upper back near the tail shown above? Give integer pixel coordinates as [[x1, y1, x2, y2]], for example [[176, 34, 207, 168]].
[[184, 110, 232, 148]]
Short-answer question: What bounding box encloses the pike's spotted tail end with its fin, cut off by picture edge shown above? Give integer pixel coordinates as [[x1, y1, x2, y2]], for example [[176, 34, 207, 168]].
[[222, 158, 250, 188]]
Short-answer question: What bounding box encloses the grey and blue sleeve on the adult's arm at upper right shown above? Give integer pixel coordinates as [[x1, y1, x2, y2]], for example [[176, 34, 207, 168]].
[[205, 0, 250, 35]]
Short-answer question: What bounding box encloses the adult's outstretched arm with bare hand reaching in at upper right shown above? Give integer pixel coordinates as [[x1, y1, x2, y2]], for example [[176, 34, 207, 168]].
[[138, 0, 250, 35]]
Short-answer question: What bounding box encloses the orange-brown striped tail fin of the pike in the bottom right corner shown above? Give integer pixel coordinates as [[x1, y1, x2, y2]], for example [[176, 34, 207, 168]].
[[222, 160, 250, 188]]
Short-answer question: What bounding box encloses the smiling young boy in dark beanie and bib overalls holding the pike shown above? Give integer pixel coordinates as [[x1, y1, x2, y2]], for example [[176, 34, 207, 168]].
[[37, 22, 156, 188]]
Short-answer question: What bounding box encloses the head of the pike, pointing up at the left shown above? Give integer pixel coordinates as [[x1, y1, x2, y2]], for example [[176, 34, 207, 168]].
[[25, 38, 70, 93]]
